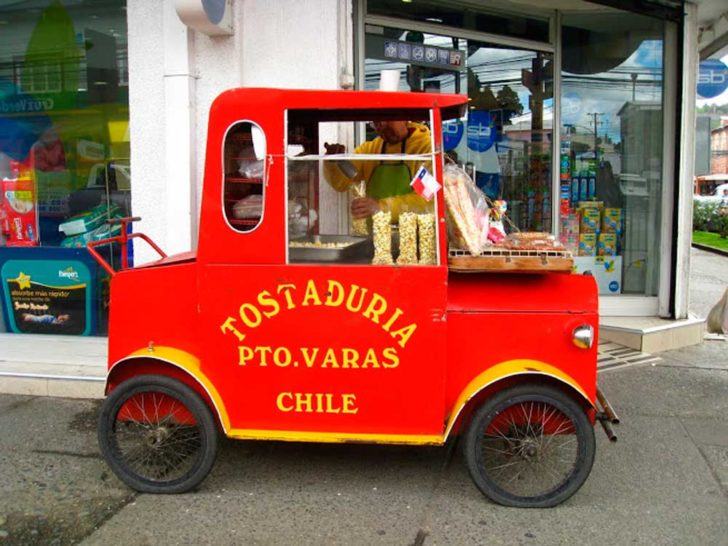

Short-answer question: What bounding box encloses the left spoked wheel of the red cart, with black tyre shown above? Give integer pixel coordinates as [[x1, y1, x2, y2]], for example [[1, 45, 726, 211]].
[[98, 375, 217, 493]]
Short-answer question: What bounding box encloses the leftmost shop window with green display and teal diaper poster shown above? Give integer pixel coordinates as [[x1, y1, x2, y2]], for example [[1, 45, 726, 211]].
[[0, 0, 131, 335]]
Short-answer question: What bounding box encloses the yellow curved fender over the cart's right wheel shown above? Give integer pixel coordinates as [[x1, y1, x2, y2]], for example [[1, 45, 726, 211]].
[[445, 359, 594, 438]]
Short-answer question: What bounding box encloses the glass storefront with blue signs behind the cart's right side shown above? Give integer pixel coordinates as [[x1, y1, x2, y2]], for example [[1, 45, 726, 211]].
[[359, 0, 680, 315]]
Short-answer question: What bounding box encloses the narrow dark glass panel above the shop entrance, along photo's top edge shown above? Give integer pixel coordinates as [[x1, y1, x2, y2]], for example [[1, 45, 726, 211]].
[[367, 0, 549, 42]]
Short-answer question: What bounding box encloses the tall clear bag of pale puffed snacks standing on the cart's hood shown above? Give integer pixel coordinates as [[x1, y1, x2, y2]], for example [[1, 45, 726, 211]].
[[443, 165, 490, 256]]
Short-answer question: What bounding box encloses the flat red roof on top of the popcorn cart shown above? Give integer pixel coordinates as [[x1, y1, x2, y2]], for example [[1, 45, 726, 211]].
[[215, 87, 468, 119]]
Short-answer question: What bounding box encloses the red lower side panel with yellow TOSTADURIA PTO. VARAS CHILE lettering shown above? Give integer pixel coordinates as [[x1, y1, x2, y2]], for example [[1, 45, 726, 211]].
[[201, 264, 446, 441]]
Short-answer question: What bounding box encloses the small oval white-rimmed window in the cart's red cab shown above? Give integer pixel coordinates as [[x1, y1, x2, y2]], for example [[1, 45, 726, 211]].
[[223, 121, 266, 232]]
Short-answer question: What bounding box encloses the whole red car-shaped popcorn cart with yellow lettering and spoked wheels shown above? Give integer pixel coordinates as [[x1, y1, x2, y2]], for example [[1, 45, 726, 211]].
[[88, 89, 617, 507]]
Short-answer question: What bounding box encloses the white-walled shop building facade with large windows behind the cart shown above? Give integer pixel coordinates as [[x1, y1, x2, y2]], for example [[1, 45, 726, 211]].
[[0, 0, 726, 350]]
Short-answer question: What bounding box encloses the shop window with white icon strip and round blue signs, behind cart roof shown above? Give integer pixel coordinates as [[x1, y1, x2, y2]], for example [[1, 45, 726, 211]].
[[365, 25, 553, 232]]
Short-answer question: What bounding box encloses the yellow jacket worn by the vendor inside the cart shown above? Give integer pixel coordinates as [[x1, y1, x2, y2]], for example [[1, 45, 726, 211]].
[[324, 122, 433, 222]]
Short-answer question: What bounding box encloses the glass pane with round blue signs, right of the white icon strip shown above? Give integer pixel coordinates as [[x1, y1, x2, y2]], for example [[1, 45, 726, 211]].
[[458, 41, 553, 232]]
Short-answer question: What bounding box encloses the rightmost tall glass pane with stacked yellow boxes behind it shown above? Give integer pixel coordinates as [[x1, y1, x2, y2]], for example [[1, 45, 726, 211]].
[[560, 11, 664, 296]]
